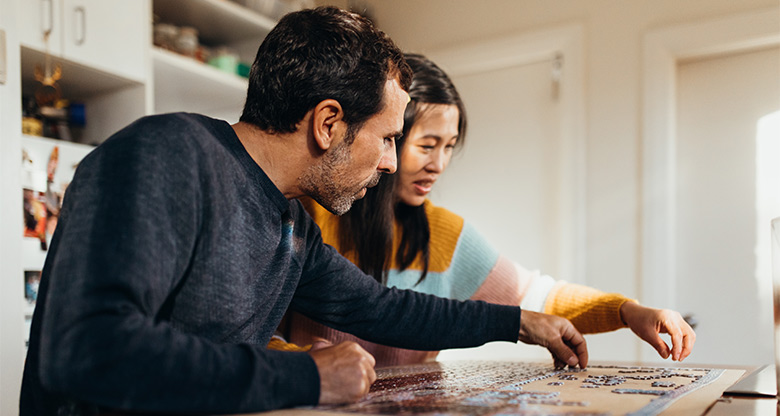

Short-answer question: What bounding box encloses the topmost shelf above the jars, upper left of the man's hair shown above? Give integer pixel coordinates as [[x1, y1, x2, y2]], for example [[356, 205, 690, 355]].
[[154, 0, 276, 46]]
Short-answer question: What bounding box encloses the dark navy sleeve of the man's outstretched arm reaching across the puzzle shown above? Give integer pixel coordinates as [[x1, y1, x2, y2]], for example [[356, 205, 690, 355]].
[[291, 213, 520, 350]]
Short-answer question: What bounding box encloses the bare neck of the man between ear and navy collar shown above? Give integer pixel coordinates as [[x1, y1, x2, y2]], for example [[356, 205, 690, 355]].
[[232, 122, 310, 199]]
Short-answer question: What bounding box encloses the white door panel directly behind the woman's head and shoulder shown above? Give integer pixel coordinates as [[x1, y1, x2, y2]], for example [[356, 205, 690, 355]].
[[431, 60, 558, 275]]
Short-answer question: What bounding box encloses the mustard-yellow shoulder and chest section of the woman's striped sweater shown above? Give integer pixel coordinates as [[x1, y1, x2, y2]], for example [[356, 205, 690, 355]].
[[300, 198, 463, 273]]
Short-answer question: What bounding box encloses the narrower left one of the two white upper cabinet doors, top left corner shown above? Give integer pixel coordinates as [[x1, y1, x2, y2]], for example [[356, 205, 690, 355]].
[[16, 0, 62, 55]]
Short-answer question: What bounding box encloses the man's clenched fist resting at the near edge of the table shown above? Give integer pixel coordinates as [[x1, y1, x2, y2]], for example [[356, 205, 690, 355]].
[[309, 342, 376, 404]]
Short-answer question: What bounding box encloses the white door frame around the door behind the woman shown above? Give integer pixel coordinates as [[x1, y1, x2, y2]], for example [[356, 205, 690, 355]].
[[428, 24, 586, 284]]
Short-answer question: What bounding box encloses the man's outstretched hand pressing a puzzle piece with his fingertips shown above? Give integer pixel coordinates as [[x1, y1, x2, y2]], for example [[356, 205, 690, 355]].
[[518, 310, 588, 368]]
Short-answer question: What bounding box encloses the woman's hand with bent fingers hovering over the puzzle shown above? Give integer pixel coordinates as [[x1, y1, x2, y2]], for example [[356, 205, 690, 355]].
[[620, 302, 696, 361]]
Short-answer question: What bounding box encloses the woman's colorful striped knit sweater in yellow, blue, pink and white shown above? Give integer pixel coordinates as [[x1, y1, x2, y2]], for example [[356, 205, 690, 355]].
[[280, 200, 630, 367]]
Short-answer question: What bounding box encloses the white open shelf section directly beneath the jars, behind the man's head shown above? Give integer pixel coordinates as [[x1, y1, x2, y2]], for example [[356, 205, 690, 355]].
[[152, 48, 248, 117]]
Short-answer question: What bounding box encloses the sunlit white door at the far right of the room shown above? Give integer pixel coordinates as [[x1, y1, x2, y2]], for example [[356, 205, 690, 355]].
[[675, 47, 780, 365]]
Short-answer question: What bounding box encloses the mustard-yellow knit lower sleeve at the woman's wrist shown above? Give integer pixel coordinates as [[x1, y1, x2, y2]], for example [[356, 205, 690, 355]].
[[544, 282, 636, 334]]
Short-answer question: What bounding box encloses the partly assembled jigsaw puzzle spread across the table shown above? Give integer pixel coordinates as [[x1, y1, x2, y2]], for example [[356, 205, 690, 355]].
[[316, 361, 741, 416]]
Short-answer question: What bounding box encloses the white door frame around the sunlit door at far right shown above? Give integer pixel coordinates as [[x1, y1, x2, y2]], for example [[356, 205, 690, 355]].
[[640, 8, 780, 309]]
